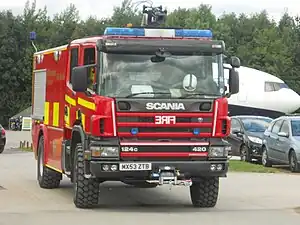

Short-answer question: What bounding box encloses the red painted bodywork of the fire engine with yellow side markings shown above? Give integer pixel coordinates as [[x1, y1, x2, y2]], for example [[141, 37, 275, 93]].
[[32, 36, 230, 171]]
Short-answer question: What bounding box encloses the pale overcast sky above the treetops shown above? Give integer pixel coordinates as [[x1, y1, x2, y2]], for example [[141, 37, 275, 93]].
[[0, 0, 300, 20]]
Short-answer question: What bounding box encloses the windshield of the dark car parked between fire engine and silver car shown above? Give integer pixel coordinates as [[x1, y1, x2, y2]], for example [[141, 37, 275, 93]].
[[241, 118, 272, 132]]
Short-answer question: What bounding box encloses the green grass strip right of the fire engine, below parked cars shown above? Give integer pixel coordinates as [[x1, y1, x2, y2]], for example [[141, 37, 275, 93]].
[[229, 160, 284, 173]]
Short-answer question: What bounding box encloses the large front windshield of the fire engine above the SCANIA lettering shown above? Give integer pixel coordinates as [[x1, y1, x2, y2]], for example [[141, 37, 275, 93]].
[[99, 53, 224, 98]]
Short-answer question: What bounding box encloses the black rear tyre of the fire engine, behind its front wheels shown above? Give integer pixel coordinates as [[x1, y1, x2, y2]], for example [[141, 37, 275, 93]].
[[37, 136, 62, 189]]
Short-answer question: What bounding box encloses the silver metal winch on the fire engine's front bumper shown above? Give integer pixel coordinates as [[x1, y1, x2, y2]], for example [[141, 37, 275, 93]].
[[147, 166, 192, 186]]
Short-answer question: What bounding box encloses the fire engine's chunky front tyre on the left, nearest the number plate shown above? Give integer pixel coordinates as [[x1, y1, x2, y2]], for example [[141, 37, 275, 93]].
[[73, 144, 100, 208]]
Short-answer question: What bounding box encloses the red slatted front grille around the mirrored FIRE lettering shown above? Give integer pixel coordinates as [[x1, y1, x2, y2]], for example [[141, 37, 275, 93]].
[[117, 112, 213, 138]]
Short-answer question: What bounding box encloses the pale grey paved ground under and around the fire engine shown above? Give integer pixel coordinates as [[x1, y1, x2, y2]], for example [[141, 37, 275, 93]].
[[0, 151, 300, 225]]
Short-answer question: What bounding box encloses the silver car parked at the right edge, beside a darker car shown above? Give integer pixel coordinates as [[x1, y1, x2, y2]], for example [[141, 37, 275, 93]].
[[261, 115, 300, 172]]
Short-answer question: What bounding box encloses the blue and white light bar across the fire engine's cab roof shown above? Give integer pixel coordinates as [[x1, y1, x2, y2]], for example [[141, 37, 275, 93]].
[[104, 27, 212, 38]]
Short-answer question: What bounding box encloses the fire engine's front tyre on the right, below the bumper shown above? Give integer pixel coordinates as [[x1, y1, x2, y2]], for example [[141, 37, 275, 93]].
[[190, 177, 219, 208]]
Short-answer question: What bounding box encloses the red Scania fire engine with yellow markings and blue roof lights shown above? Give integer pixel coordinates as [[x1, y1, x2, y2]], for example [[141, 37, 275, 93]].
[[32, 4, 239, 208]]
